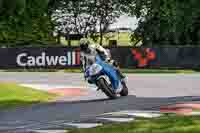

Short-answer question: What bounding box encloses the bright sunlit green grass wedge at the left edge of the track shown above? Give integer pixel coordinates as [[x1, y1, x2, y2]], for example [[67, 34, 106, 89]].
[[0, 83, 56, 109]]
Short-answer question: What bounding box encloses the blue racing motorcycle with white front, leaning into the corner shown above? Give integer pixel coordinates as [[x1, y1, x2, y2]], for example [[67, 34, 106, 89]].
[[85, 56, 128, 99]]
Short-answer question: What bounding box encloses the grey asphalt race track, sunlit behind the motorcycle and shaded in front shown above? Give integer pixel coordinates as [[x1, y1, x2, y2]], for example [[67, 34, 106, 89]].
[[0, 73, 200, 133]]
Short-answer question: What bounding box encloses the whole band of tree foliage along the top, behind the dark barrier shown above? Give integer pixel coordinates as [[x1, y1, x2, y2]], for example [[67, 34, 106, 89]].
[[0, 0, 200, 46]]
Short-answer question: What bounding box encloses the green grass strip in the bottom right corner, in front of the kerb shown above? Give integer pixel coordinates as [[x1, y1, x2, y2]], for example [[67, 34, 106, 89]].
[[68, 116, 200, 133]]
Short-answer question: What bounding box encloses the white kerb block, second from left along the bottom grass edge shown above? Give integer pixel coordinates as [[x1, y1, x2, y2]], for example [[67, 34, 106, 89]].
[[64, 123, 103, 128]]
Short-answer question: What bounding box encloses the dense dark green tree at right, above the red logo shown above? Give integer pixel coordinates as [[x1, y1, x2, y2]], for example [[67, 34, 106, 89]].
[[132, 0, 200, 45]]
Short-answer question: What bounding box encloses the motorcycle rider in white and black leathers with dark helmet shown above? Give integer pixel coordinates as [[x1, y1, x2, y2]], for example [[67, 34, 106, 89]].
[[80, 38, 125, 92]]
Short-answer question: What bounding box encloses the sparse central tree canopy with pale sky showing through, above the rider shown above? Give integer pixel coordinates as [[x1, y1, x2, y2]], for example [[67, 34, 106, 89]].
[[53, 0, 126, 45]]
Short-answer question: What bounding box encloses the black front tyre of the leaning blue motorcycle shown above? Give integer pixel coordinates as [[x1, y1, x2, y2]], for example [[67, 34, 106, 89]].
[[97, 78, 117, 99]]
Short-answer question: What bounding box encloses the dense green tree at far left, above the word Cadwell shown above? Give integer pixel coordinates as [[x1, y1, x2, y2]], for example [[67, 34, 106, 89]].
[[0, 0, 53, 45]]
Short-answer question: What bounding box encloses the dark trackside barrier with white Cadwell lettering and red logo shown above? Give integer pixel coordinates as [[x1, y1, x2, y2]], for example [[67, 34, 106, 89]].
[[0, 47, 200, 69]]
